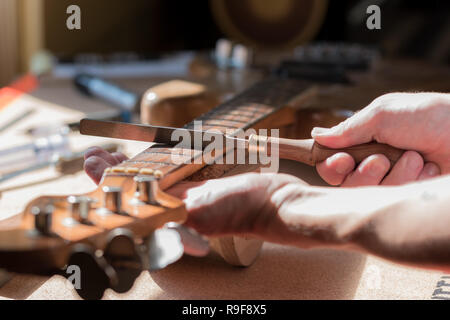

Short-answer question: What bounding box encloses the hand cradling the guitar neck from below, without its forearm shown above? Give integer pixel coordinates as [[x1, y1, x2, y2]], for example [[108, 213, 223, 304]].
[[84, 147, 306, 246]]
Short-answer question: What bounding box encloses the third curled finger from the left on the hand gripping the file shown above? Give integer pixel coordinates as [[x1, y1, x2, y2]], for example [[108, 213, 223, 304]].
[[382, 151, 424, 185]]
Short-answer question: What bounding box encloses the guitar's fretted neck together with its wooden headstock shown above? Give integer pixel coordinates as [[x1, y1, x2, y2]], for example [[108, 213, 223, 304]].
[[0, 79, 312, 284]]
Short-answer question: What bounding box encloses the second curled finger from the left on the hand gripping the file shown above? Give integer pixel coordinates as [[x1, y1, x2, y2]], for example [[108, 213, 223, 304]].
[[342, 154, 390, 187]]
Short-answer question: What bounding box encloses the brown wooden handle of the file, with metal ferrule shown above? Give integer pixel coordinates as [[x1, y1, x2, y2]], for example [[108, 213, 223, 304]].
[[249, 135, 405, 167]]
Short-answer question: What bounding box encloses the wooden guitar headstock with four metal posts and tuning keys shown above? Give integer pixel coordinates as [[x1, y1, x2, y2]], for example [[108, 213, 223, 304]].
[[0, 167, 186, 298]]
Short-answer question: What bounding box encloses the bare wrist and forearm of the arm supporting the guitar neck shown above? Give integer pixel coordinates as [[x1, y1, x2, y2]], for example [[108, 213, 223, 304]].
[[268, 176, 450, 271]]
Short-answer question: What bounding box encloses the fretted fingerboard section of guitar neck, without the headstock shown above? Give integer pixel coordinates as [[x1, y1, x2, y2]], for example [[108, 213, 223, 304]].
[[105, 78, 306, 189]]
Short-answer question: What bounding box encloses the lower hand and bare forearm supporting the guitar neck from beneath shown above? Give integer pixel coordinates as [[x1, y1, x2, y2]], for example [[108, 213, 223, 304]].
[[86, 149, 450, 272]]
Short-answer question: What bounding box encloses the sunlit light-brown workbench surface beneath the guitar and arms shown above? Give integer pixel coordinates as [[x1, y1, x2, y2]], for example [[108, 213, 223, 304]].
[[0, 70, 442, 299]]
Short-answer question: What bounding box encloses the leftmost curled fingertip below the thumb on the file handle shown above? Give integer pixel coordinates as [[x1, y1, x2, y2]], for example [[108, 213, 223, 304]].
[[316, 152, 355, 186]]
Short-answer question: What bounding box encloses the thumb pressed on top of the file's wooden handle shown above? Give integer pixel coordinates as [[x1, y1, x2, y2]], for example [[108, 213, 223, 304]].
[[311, 109, 376, 148]]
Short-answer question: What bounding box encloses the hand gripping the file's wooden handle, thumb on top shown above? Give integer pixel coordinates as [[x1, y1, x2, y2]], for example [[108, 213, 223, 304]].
[[311, 93, 450, 187]]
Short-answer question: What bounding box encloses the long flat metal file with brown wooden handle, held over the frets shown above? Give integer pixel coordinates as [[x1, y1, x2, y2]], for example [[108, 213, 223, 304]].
[[80, 119, 405, 166]]
